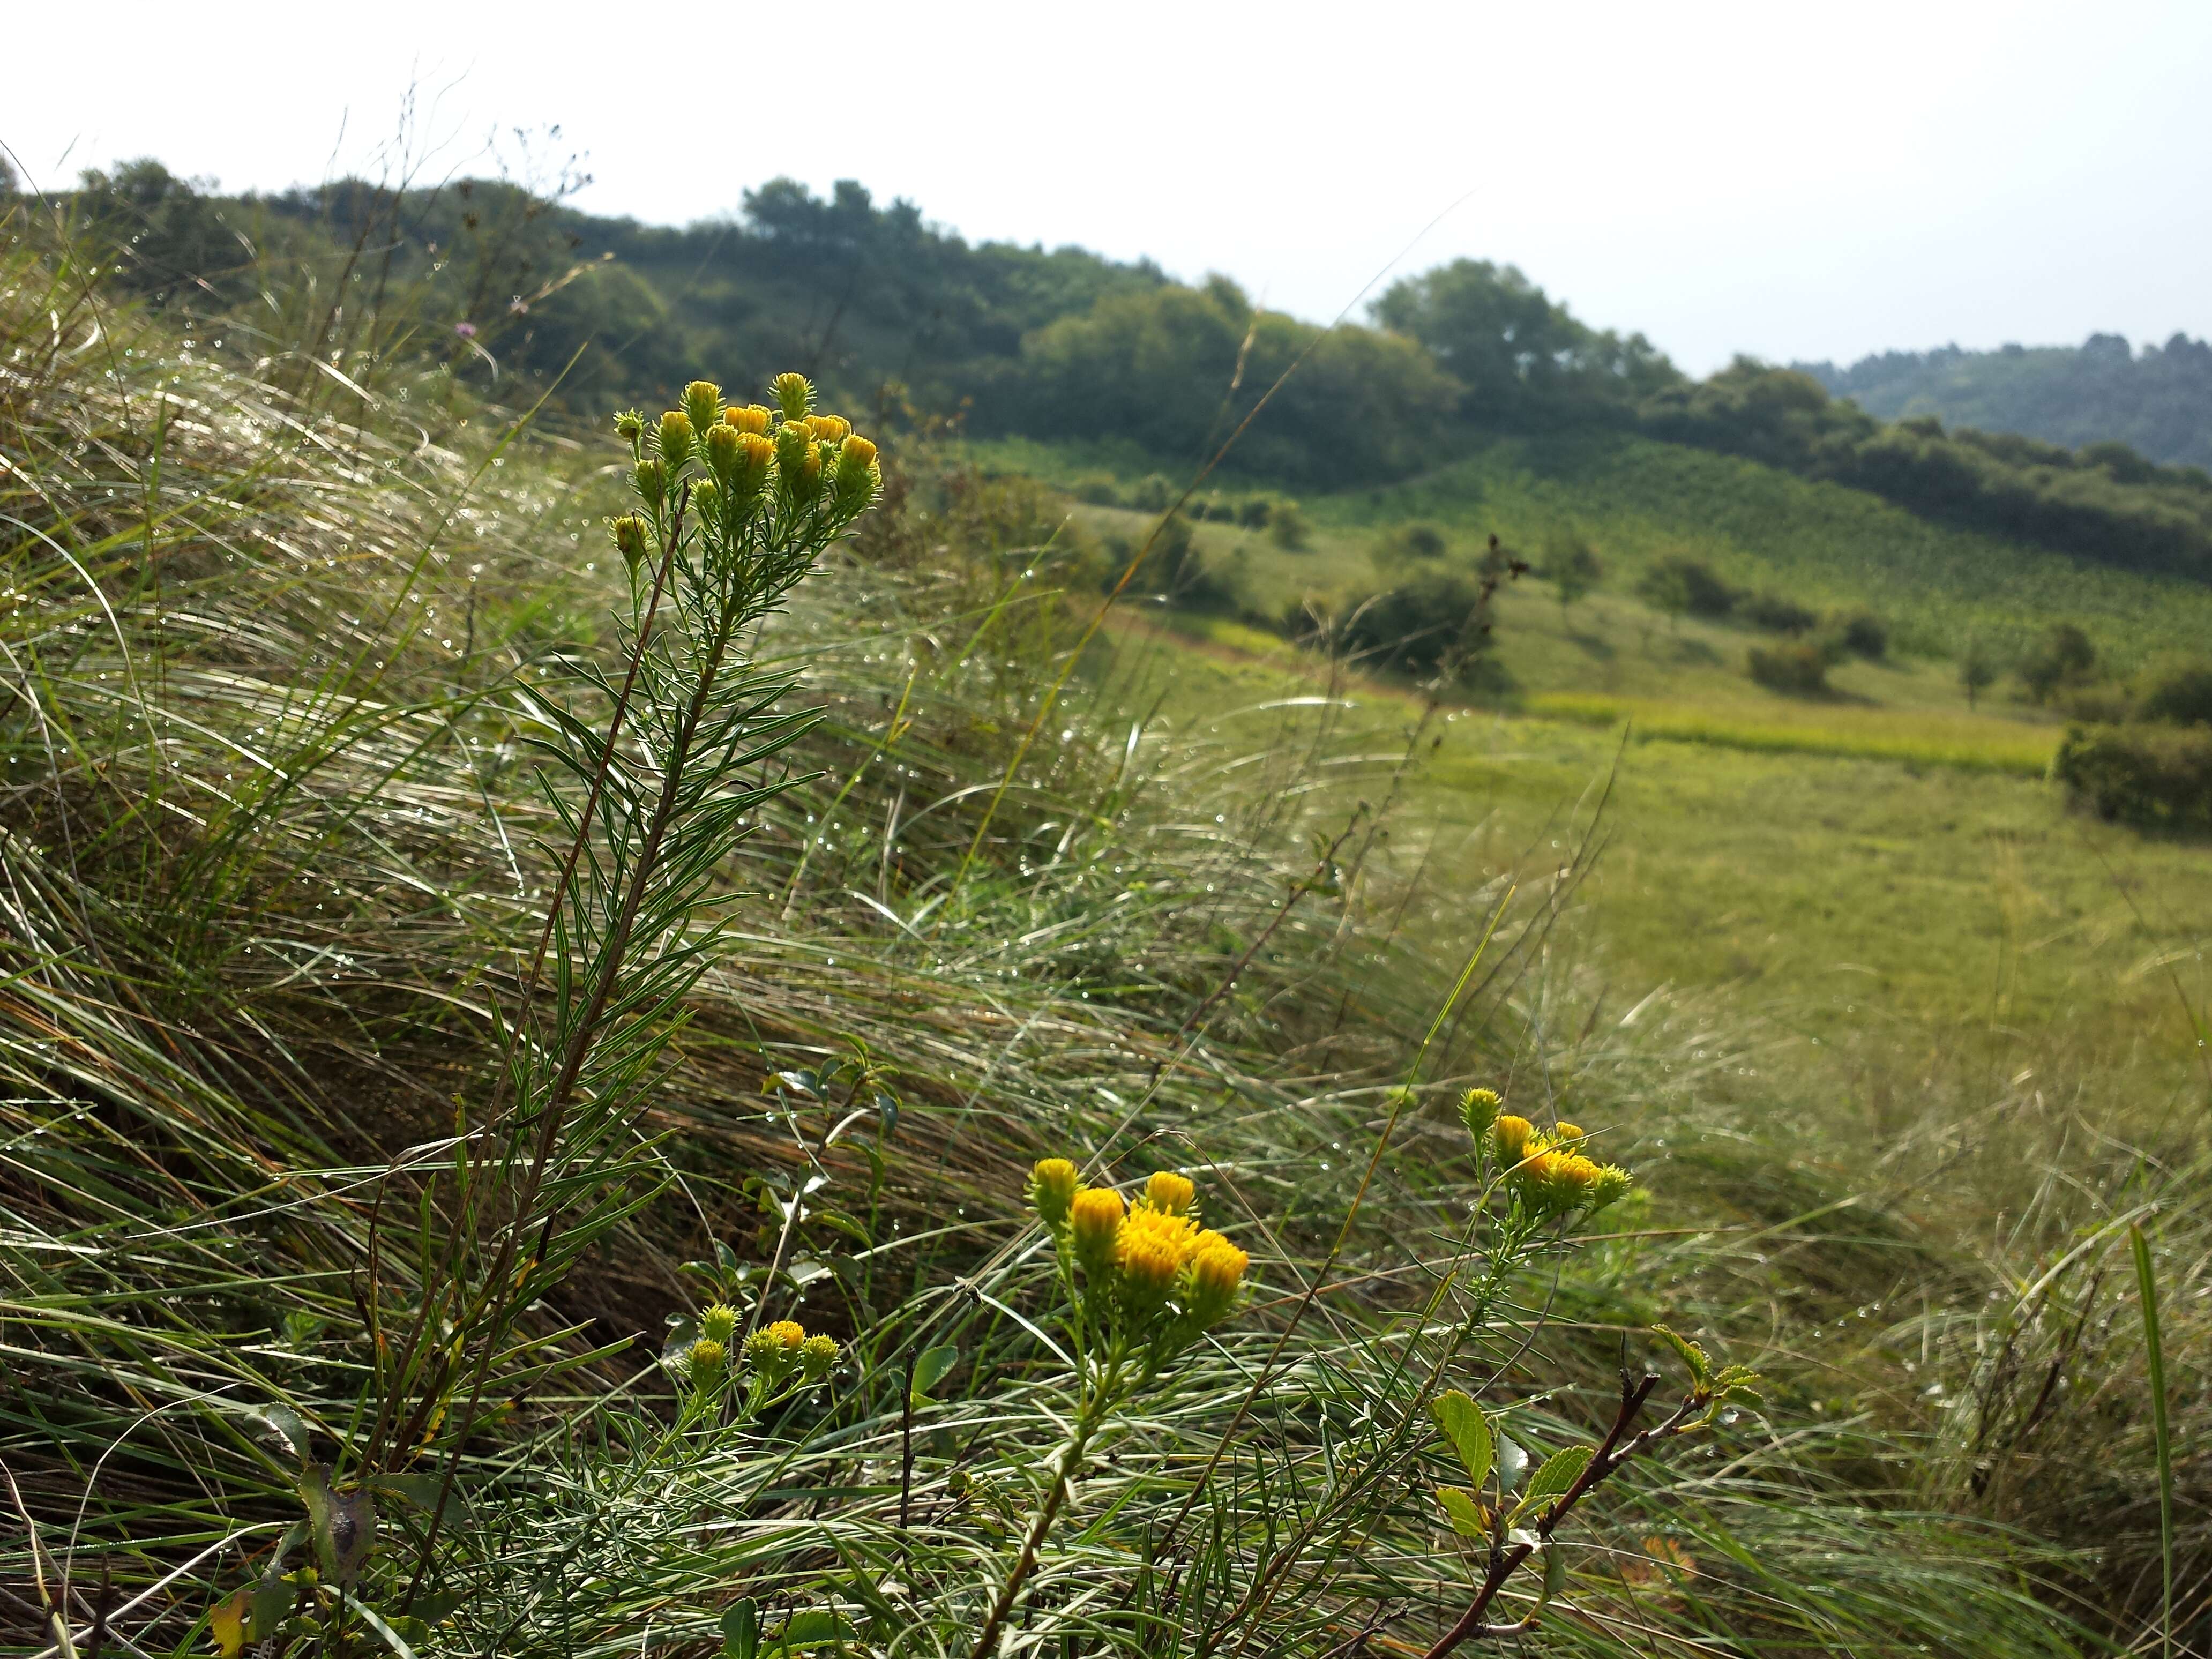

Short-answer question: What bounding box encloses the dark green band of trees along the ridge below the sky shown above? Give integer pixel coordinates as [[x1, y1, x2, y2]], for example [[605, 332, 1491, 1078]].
[[47, 167, 2212, 575]]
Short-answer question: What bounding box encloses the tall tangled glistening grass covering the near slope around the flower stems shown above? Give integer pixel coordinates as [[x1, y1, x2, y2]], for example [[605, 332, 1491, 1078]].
[[0, 208, 2168, 1655]]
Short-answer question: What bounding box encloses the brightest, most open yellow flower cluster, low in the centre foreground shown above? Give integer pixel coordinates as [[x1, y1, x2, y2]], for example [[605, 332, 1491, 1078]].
[[1029, 1157, 1252, 1341]]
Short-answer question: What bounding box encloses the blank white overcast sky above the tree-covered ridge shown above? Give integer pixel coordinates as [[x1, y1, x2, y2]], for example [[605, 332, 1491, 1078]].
[[0, 0, 2212, 372]]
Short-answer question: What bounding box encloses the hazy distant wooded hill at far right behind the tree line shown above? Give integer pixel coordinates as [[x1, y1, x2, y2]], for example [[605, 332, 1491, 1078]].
[[1792, 334, 2212, 469]]
